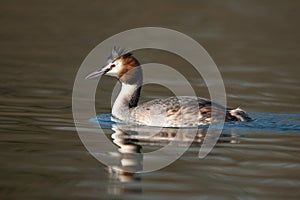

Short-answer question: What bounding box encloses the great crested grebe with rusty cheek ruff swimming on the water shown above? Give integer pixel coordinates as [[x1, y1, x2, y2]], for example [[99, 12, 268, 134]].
[[86, 47, 251, 127]]
